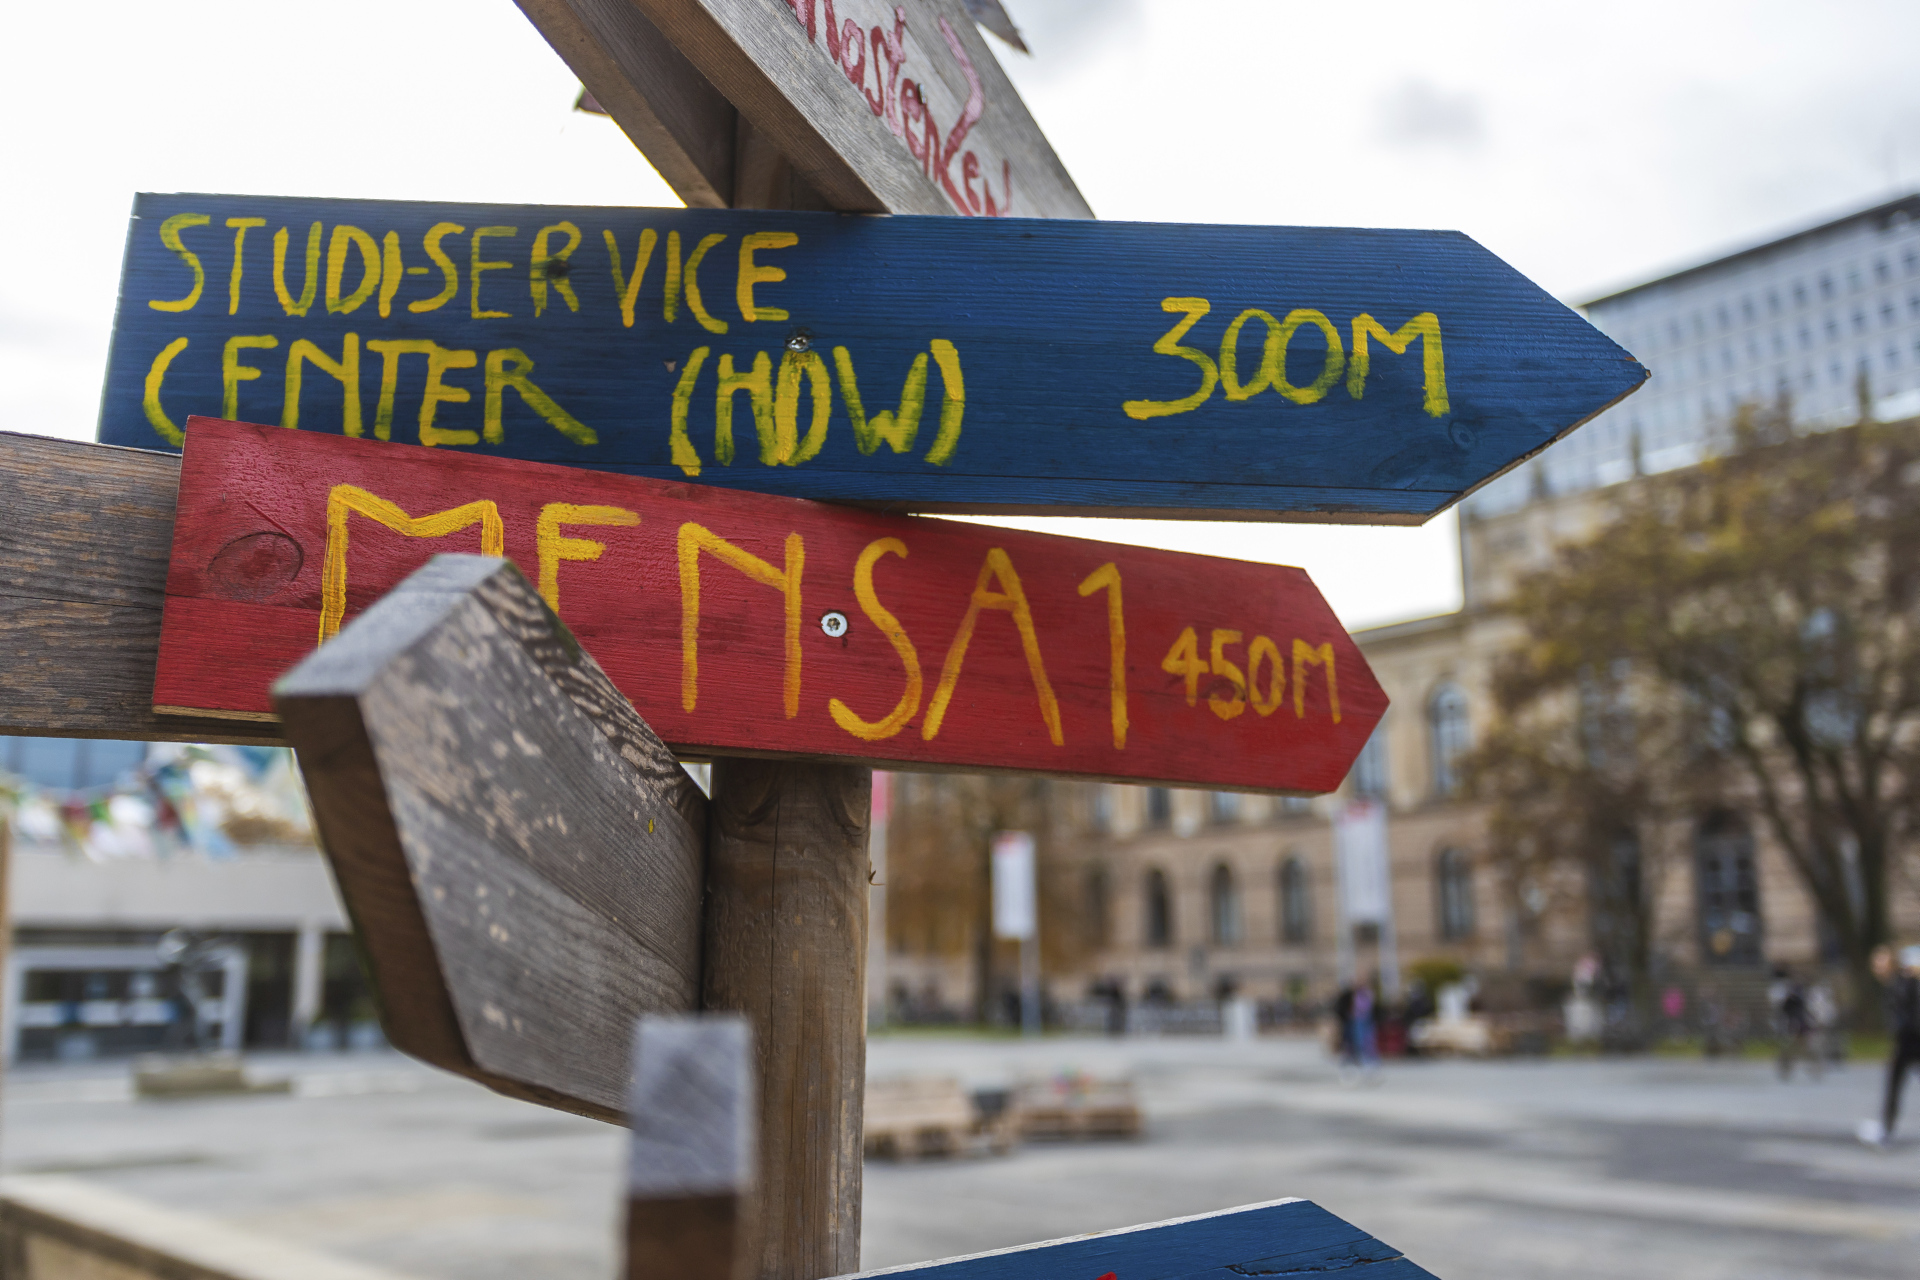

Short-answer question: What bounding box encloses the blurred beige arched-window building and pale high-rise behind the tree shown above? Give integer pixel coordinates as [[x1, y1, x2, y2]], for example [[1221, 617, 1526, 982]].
[[887, 196, 1920, 1015]]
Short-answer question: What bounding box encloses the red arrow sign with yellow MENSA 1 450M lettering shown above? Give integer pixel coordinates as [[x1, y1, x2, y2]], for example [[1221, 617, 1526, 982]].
[[154, 418, 1386, 793]]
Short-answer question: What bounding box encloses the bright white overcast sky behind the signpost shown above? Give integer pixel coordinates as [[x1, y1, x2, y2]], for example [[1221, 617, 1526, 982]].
[[0, 0, 1920, 626]]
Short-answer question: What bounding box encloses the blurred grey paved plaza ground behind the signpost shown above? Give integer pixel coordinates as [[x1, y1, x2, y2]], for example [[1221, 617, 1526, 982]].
[[0, 1034, 1920, 1280]]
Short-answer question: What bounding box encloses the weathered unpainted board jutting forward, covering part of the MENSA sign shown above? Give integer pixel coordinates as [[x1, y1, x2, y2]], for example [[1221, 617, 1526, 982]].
[[275, 557, 703, 1119]]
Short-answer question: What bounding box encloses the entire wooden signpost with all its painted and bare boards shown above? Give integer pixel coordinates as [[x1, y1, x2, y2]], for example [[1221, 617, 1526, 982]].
[[0, 0, 1645, 1280]]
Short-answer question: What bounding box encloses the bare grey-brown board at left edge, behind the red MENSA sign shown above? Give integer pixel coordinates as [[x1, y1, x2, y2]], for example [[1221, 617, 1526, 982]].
[[0, 432, 280, 743]]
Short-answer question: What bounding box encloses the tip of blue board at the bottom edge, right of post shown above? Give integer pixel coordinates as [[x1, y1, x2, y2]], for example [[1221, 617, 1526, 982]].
[[833, 1199, 1432, 1280]]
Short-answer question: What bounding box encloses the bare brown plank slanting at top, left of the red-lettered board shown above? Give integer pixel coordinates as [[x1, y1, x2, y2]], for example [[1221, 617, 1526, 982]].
[[516, 0, 737, 209]]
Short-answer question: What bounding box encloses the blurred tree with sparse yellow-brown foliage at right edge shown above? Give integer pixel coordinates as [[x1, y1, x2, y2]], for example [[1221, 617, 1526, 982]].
[[1475, 411, 1920, 1007]]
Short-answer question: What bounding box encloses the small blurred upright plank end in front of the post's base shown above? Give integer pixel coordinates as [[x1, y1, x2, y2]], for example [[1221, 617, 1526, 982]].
[[624, 1015, 756, 1280]]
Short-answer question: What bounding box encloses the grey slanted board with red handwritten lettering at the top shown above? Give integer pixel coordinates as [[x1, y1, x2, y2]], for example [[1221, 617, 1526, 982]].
[[636, 0, 1092, 219]]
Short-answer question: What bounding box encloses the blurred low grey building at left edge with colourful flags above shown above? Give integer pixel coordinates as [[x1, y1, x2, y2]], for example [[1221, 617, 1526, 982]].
[[0, 739, 376, 1061]]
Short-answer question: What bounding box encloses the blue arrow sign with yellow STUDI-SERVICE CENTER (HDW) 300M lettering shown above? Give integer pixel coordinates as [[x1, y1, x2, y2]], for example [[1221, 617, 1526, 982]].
[[100, 196, 1645, 524]]
